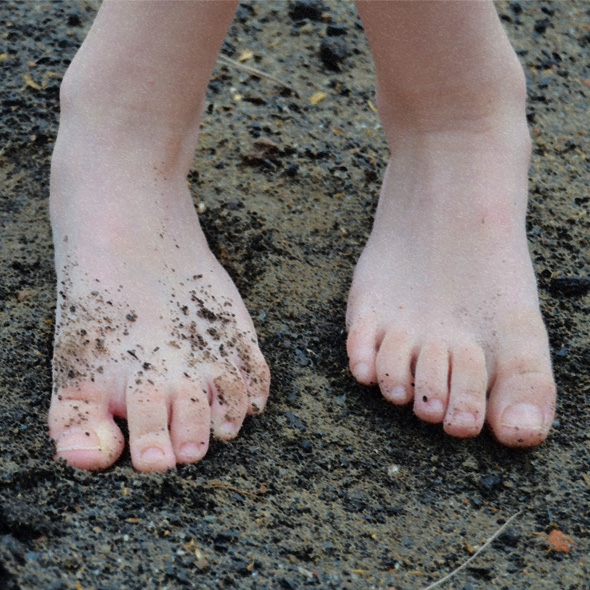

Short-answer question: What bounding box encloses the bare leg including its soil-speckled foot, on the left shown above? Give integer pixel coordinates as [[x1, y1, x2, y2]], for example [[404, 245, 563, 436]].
[[49, 0, 269, 471]]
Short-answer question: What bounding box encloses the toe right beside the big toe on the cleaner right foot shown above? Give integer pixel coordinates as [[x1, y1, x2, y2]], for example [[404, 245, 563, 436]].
[[444, 344, 488, 438]]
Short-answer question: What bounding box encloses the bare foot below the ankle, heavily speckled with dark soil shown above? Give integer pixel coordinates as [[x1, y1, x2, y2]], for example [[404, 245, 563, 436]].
[[49, 123, 269, 471]]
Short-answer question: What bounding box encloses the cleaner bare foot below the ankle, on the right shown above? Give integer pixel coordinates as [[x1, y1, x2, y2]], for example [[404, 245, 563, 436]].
[[347, 125, 555, 447]]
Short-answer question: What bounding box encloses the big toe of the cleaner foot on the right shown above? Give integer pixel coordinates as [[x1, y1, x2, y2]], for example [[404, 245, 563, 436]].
[[488, 371, 556, 447]]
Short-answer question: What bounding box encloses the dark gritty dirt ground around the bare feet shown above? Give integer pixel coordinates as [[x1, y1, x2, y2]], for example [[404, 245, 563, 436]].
[[0, 0, 590, 590]]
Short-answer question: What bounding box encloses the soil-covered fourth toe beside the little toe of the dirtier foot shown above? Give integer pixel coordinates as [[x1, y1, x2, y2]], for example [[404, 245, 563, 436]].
[[210, 362, 248, 440]]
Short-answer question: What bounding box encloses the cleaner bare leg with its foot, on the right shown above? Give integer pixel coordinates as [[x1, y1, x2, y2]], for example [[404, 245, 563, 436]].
[[348, 0, 555, 446]]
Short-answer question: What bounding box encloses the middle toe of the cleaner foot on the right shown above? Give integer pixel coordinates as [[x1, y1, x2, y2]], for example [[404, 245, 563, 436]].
[[414, 341, 449, 424]]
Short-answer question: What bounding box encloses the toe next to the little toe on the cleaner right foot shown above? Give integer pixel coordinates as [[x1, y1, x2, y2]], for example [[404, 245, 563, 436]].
[[376, 331, 414, 404]]
